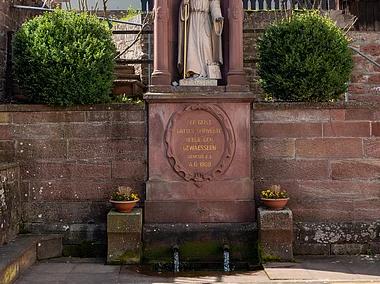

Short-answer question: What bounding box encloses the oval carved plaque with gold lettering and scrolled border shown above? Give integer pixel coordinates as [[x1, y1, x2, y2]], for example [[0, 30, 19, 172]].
[[166, 104, 235, 187]]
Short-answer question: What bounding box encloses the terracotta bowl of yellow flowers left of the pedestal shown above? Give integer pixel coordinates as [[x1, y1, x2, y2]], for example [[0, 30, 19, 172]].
[[109, 186, 140, 213]]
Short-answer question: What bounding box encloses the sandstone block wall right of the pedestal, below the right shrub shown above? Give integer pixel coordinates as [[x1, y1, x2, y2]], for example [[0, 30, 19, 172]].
[[252, 103, 380, 254]]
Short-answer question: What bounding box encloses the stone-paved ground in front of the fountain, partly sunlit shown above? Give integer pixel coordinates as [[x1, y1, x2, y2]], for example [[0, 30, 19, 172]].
[[15, 255, 380, 284]]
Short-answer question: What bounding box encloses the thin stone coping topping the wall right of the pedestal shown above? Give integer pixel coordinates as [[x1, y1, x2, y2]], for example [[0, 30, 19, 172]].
[[253, 102, 380, 110]]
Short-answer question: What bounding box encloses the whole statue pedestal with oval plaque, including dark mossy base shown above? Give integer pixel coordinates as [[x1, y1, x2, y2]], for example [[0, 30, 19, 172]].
[[143, 92, 256, 260]]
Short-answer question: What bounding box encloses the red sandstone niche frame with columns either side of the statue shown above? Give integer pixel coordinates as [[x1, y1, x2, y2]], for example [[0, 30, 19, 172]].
[[151, 0, 247, 87]]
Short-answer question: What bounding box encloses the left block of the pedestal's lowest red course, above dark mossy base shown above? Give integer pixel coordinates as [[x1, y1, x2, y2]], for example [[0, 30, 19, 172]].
[[144, 201, 201, 223]]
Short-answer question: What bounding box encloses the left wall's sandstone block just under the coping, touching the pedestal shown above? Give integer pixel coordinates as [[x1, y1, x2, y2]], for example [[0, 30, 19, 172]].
[[86, 109, 146, 122]]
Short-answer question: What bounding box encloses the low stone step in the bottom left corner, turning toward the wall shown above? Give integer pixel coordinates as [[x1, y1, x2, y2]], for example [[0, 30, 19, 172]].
[[0, 234, 63, 284]]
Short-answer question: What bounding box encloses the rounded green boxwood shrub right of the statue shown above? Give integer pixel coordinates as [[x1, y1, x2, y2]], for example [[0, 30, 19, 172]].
[[258, 11, 353, 102]]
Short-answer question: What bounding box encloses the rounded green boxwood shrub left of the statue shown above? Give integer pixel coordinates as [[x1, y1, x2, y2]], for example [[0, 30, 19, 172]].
[[13, 10, 115, 106]]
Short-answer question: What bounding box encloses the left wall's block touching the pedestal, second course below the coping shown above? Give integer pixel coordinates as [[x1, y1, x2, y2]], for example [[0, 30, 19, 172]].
[[68, 123, 146, 139]]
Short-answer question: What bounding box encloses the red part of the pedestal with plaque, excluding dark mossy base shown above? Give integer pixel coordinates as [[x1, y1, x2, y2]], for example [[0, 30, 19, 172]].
[[144, 94, 255, 224]]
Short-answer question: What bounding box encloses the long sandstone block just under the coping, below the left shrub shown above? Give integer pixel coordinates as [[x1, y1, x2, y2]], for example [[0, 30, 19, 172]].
[[13, 111, 85, 124]]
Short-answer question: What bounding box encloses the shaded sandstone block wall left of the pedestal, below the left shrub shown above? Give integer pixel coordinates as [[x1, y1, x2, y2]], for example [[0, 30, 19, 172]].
[[0, 104, 146, 247]]
